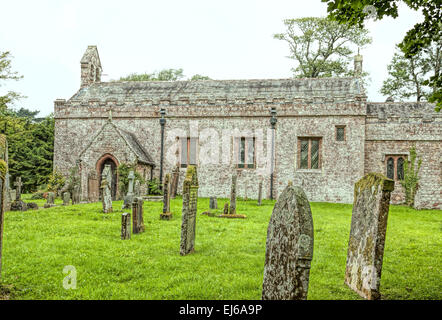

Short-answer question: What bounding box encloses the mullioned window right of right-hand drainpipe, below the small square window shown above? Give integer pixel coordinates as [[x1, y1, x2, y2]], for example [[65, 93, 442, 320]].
[[298, 137, 322, 169]]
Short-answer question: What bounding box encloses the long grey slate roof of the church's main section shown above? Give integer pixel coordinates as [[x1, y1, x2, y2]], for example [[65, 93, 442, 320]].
[[70, 78, 365, 102]]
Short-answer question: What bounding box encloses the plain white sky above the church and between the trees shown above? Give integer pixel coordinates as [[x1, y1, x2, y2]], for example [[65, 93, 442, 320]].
[[0, 0, 422, 116]]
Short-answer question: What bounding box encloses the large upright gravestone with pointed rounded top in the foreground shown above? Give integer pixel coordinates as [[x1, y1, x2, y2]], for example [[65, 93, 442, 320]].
[[262, 182, 313, 300]]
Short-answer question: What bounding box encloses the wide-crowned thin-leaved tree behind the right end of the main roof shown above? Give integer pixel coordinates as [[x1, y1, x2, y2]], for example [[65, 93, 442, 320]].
[[274, 17, 371, 78]]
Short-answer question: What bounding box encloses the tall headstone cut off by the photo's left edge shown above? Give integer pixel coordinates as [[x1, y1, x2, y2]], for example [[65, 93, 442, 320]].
[[0, 134, 8, 279]]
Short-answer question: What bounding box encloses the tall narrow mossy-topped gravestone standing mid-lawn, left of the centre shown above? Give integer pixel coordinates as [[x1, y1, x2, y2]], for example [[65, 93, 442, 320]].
[[180, 165, 198, 256]]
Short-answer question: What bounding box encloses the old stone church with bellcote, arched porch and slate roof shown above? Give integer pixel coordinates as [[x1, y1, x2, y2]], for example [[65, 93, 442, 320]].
[[54, 46, 442, 209]]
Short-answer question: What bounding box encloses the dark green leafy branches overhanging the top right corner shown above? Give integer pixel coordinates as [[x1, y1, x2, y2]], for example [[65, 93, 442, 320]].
[[322, 0, 442, 111]]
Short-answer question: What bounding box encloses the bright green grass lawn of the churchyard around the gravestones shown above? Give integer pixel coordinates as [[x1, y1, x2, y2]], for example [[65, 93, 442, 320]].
[[0, 197, 442, 299]]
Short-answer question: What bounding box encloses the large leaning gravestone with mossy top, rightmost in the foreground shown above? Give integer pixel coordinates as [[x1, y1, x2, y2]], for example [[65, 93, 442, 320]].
[[345, 173, 394, 300]]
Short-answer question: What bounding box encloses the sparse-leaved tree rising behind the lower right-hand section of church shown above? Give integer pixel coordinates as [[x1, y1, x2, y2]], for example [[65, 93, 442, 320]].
[[381, 41, 442, 101]]
